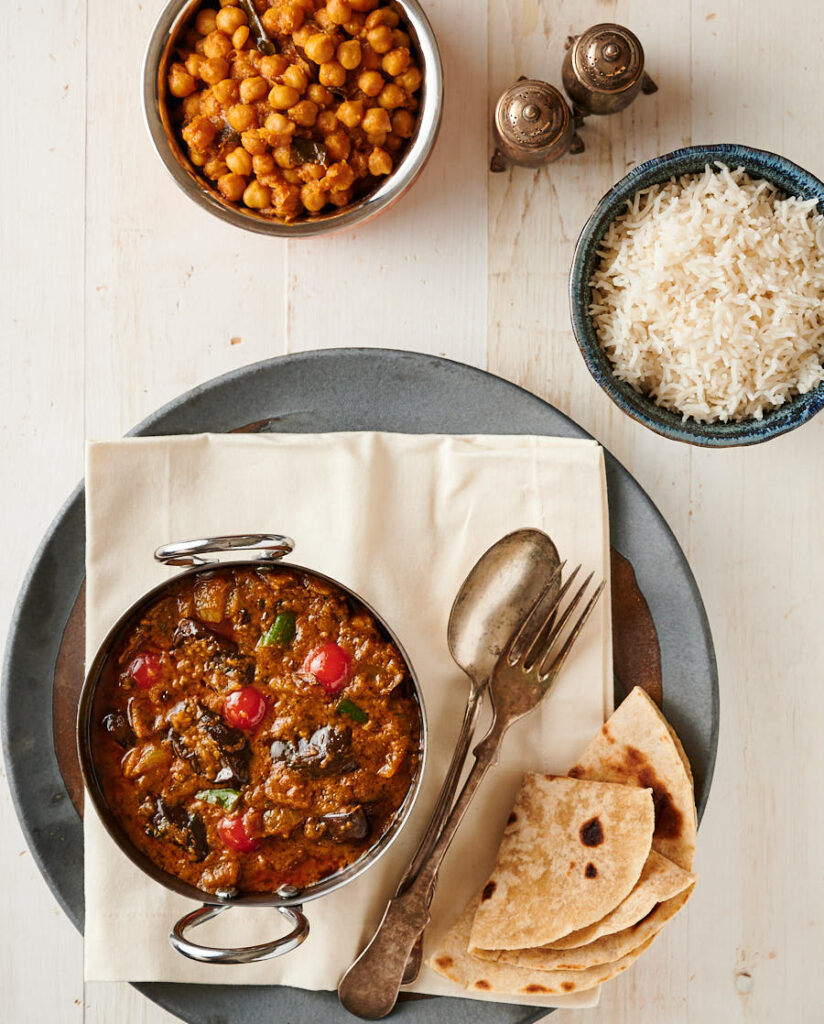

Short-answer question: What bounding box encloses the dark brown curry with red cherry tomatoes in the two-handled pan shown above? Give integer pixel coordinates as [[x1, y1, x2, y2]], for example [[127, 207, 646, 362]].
[[91, 567, 421, 893]]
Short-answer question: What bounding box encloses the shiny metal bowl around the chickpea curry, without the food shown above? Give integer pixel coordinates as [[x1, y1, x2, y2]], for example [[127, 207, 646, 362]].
[[142, 0, 443, 239]]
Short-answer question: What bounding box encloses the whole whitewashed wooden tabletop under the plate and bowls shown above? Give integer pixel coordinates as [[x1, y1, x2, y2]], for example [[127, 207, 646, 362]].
[[0, 0, 824, 1024]]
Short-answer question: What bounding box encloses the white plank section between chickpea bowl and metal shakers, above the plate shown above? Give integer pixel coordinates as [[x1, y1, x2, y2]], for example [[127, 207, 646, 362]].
[[288, 0, 486, 366]]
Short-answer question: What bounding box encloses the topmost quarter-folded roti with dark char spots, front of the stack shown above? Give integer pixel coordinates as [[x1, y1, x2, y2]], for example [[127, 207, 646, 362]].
[[470, 774, 654, 949]]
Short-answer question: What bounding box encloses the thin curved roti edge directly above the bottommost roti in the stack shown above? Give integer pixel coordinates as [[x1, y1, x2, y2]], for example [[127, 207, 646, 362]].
[[493, 883, 695, 972]]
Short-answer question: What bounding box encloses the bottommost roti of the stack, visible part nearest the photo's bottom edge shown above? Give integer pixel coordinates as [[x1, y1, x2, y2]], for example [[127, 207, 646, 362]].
[[428, 894, 652, 995]]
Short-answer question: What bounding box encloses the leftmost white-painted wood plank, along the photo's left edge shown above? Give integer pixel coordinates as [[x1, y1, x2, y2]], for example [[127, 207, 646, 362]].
[[0, 0, 85, 1024]]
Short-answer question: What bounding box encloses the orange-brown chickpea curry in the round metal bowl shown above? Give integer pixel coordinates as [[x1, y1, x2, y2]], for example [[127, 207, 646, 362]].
[[166, 0, 422, 221]]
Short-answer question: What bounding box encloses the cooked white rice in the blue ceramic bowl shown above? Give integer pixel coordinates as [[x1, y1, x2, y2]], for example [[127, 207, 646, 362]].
[[590, 164, 824, 422]]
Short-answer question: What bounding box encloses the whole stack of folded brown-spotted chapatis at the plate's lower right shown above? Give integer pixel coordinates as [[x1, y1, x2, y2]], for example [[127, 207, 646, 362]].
[[429, 687, 696, 995]]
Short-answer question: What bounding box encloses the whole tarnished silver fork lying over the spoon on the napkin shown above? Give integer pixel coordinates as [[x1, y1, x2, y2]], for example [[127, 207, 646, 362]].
[[338, 565, 604, 1020]]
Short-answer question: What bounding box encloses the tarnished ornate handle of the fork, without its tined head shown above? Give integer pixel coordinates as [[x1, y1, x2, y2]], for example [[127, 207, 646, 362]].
[[338, 719, 507, 1020]]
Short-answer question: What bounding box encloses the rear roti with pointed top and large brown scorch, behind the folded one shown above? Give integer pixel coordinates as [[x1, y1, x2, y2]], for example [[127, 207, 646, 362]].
[[569, 686, 697, 868]]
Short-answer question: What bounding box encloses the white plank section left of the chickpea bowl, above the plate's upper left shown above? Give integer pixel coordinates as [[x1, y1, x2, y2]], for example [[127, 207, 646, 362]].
[[86, 0, 286, 436]]
